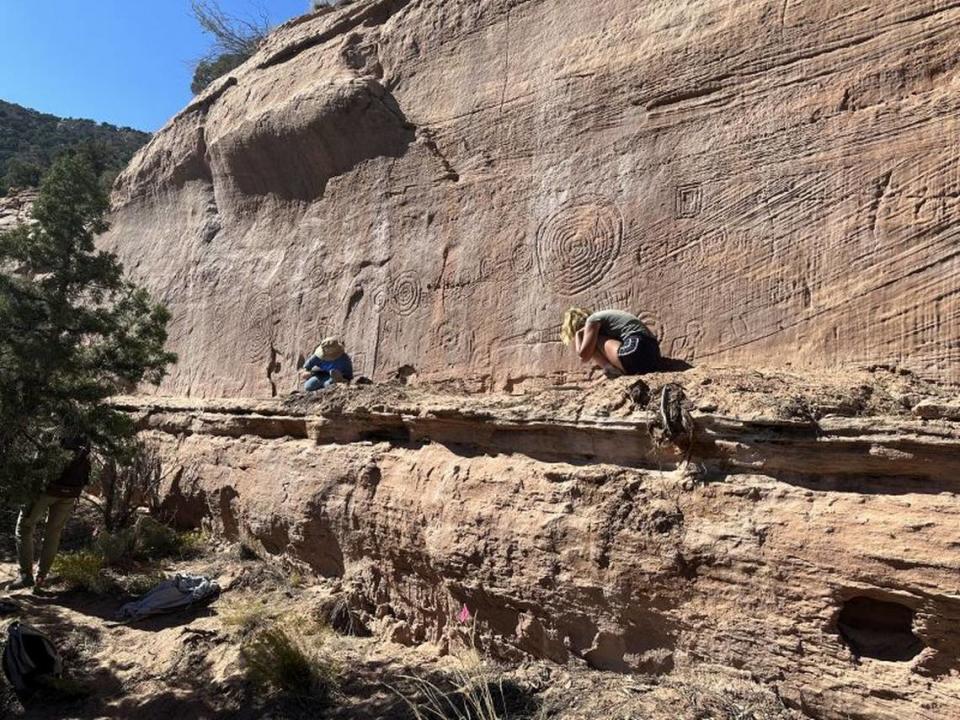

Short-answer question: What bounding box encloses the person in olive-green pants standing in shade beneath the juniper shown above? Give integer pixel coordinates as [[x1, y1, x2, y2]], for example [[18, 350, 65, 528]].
[[10, 438, 90, 590]]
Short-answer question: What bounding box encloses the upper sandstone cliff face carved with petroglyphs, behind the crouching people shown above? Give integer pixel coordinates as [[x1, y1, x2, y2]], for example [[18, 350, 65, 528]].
[[105, 0, 960, 396]]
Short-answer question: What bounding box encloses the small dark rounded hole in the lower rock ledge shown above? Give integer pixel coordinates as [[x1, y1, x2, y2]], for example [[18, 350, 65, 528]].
[[837, 596, 925, 662]]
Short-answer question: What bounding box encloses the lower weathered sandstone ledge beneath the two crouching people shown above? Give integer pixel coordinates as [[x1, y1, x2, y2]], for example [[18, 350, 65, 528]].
[[124, 370, 960, 720]]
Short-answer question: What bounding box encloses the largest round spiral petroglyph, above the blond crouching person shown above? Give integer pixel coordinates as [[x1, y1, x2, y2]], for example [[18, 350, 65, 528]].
[[536, 199, 623, 296]]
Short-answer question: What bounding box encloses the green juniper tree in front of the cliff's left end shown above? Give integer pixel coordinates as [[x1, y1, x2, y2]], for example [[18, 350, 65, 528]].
[[0, 153, 176, 502]]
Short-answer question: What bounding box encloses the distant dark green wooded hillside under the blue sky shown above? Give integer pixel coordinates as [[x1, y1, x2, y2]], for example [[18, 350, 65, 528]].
[[0, 100, 150, 196]]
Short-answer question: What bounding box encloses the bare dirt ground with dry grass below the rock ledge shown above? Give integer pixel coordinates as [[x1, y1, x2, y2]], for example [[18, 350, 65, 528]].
[[0, 547, 802, 720]]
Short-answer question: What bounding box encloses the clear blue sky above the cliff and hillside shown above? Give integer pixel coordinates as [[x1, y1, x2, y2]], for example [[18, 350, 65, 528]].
[[0, 0, 309, 131]]
